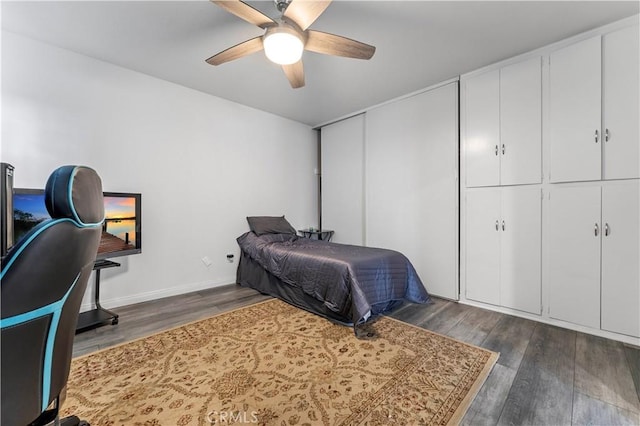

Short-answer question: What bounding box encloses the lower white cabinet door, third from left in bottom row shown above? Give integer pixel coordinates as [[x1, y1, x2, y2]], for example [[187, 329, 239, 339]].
[[548, 185, 602, 328]]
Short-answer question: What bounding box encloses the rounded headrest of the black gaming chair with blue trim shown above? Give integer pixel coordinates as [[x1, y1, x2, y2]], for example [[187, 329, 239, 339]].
[[44, 166, 104, 226]]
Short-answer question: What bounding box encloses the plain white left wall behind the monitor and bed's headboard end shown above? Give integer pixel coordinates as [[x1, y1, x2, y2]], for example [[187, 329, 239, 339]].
[[0, 32, 317, 309]]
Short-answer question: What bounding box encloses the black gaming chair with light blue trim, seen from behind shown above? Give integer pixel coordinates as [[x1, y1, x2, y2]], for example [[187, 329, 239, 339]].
[[0, 166, 104, 426]]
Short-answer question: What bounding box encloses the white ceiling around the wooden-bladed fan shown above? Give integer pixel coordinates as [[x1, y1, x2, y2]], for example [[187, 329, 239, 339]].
[[1, 0, 640, 126]]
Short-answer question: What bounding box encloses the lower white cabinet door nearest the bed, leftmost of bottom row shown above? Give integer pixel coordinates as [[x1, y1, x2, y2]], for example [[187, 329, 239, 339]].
[[465, 189, 500, 305]]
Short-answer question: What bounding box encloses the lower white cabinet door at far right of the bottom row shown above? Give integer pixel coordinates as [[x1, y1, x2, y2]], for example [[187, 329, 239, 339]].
[[602, 180, 640, 337]]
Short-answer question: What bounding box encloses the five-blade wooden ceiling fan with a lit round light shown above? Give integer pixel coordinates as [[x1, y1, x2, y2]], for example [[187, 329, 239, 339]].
[[207, 0, 376, 89]]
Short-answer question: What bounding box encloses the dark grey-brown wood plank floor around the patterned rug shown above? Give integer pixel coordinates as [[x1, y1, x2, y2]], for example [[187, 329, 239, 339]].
[[74, 285, 640, 425]]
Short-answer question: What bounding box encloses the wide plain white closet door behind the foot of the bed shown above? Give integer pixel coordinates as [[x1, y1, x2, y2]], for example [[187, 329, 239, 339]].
[[365, 83, 458, 299]]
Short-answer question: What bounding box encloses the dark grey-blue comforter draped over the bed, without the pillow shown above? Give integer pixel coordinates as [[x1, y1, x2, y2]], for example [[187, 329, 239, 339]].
[[237, 232, 429, 324]]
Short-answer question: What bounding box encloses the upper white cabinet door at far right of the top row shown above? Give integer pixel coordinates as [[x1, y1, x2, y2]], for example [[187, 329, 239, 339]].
[[603, 25, 640, 179]]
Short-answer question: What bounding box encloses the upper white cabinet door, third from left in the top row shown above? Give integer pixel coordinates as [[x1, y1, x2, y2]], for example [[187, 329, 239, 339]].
[[549, 36, 600, 182]]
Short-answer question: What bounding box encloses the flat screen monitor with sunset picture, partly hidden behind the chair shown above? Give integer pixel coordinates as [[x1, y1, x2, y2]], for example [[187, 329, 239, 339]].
[[13, 188, 142, 259]]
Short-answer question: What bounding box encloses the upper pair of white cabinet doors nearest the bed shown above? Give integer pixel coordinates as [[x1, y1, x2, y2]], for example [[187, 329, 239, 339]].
[[464, 56, 542, 187]]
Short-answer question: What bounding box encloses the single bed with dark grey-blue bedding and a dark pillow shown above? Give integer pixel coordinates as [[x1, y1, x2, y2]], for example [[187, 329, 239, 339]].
[[237, 216, 429, 326]]
